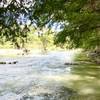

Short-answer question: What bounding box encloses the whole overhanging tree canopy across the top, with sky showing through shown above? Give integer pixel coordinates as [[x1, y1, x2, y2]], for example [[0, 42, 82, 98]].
[[0, 0, 100, 48]]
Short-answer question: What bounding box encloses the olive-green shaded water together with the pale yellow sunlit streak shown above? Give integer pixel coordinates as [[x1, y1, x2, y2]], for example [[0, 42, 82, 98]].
[[44, 64, 100, 100]]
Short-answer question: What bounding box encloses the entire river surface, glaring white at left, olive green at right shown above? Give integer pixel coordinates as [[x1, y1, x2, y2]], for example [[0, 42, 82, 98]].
[[0, 50, 100, 100]]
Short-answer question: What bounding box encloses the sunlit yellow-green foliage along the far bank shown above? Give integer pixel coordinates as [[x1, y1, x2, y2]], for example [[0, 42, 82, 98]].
[[0, 27, 58, 52]]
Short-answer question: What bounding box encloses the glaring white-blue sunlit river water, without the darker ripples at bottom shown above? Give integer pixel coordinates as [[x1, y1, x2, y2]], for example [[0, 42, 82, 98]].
[[0, 50, 79, 100]]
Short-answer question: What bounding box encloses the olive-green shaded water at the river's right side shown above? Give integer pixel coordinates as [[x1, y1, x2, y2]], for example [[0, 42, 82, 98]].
[[67, 64, 100, 100]]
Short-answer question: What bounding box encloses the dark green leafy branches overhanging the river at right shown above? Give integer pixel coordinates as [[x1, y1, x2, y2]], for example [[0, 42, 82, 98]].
[[55, 0, 100, 48]]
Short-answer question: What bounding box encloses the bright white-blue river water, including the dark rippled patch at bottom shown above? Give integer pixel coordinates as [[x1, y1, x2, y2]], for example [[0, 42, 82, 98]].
[[0, 51, 78, 100]]
